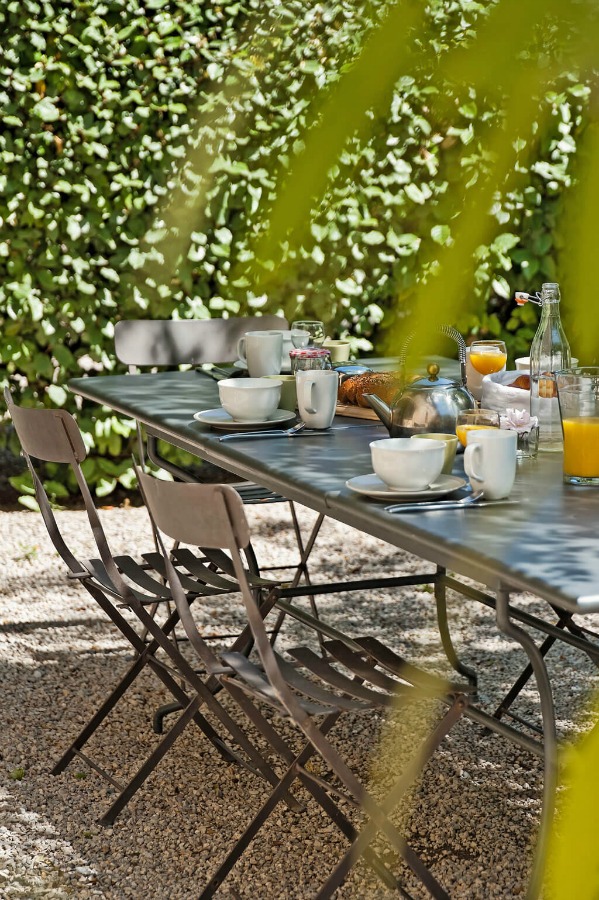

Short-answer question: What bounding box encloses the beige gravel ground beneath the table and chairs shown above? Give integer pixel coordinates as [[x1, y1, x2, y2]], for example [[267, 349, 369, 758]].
[[0, 505, 596, 900]]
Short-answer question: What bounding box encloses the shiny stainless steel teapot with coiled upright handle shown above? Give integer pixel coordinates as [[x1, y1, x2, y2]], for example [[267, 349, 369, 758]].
[[364, 325, 476, 437]]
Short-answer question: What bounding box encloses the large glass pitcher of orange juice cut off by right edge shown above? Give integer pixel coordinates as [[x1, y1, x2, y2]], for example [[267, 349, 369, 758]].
[[556, 366, 599, 485]]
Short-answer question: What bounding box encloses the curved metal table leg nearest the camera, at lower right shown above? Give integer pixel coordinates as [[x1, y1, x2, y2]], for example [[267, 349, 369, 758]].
[[496, 589, 557, 900]]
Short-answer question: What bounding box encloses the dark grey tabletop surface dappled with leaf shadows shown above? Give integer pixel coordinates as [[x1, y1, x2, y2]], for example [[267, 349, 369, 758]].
[[69, 370, 599, 612]]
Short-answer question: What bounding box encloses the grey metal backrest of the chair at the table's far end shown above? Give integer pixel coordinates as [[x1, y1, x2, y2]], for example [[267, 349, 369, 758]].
[[114, 316, 288, 366]]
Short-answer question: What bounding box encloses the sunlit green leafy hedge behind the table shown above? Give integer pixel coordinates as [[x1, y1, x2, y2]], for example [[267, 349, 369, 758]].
[[0, 0, 588, 497]]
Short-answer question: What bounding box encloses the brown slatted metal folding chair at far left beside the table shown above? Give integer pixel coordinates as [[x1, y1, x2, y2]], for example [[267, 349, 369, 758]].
[[4, 388, 296, 825]]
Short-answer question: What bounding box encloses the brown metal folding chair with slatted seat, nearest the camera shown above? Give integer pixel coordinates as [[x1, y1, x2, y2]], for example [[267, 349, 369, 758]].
[[138, 472, 466, 898]]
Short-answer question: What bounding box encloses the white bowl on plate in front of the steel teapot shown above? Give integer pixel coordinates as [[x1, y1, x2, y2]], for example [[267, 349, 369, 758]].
[[370, 438, 445, 491]]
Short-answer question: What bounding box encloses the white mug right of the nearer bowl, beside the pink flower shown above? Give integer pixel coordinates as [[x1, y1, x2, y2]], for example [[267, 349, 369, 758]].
[[464, 428, 518, 500]]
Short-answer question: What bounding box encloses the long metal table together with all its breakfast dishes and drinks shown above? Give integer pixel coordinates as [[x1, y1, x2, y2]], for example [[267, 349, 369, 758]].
[[69, 298, 599, 896]]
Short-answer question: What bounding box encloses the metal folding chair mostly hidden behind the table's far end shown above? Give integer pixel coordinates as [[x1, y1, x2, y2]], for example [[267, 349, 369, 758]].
[[114, 316, 324, 584]]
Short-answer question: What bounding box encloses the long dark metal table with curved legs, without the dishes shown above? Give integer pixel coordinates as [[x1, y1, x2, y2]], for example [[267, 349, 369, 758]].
[[69, 370, 599, 896]]
